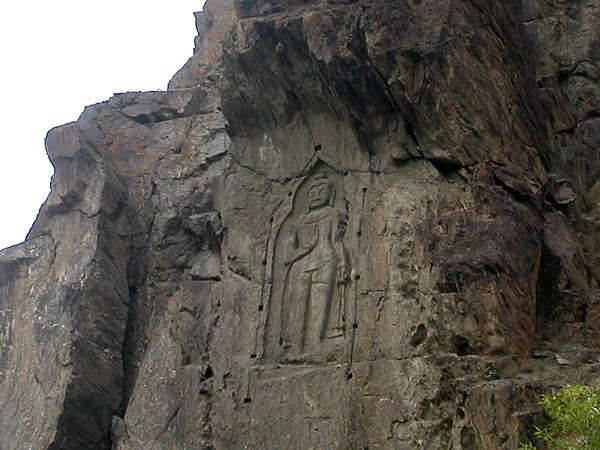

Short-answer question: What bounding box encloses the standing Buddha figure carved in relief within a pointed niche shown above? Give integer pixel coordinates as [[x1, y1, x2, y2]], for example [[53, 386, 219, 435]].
[[266, 170, 350, 357]]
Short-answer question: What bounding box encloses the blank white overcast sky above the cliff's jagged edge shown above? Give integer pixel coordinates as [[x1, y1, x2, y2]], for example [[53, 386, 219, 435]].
[[0, 0, 204, 249]]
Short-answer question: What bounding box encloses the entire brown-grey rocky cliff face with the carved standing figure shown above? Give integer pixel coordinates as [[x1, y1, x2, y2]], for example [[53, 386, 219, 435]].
[[0, 0, 600, 450]]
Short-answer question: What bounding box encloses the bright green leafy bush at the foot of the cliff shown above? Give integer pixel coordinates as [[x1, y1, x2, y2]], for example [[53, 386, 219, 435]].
[[519, 382, 600, 450]]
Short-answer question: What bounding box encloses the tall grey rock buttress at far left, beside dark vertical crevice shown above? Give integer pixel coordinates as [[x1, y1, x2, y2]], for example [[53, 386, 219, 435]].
[[0, 125, 129, 449]]
